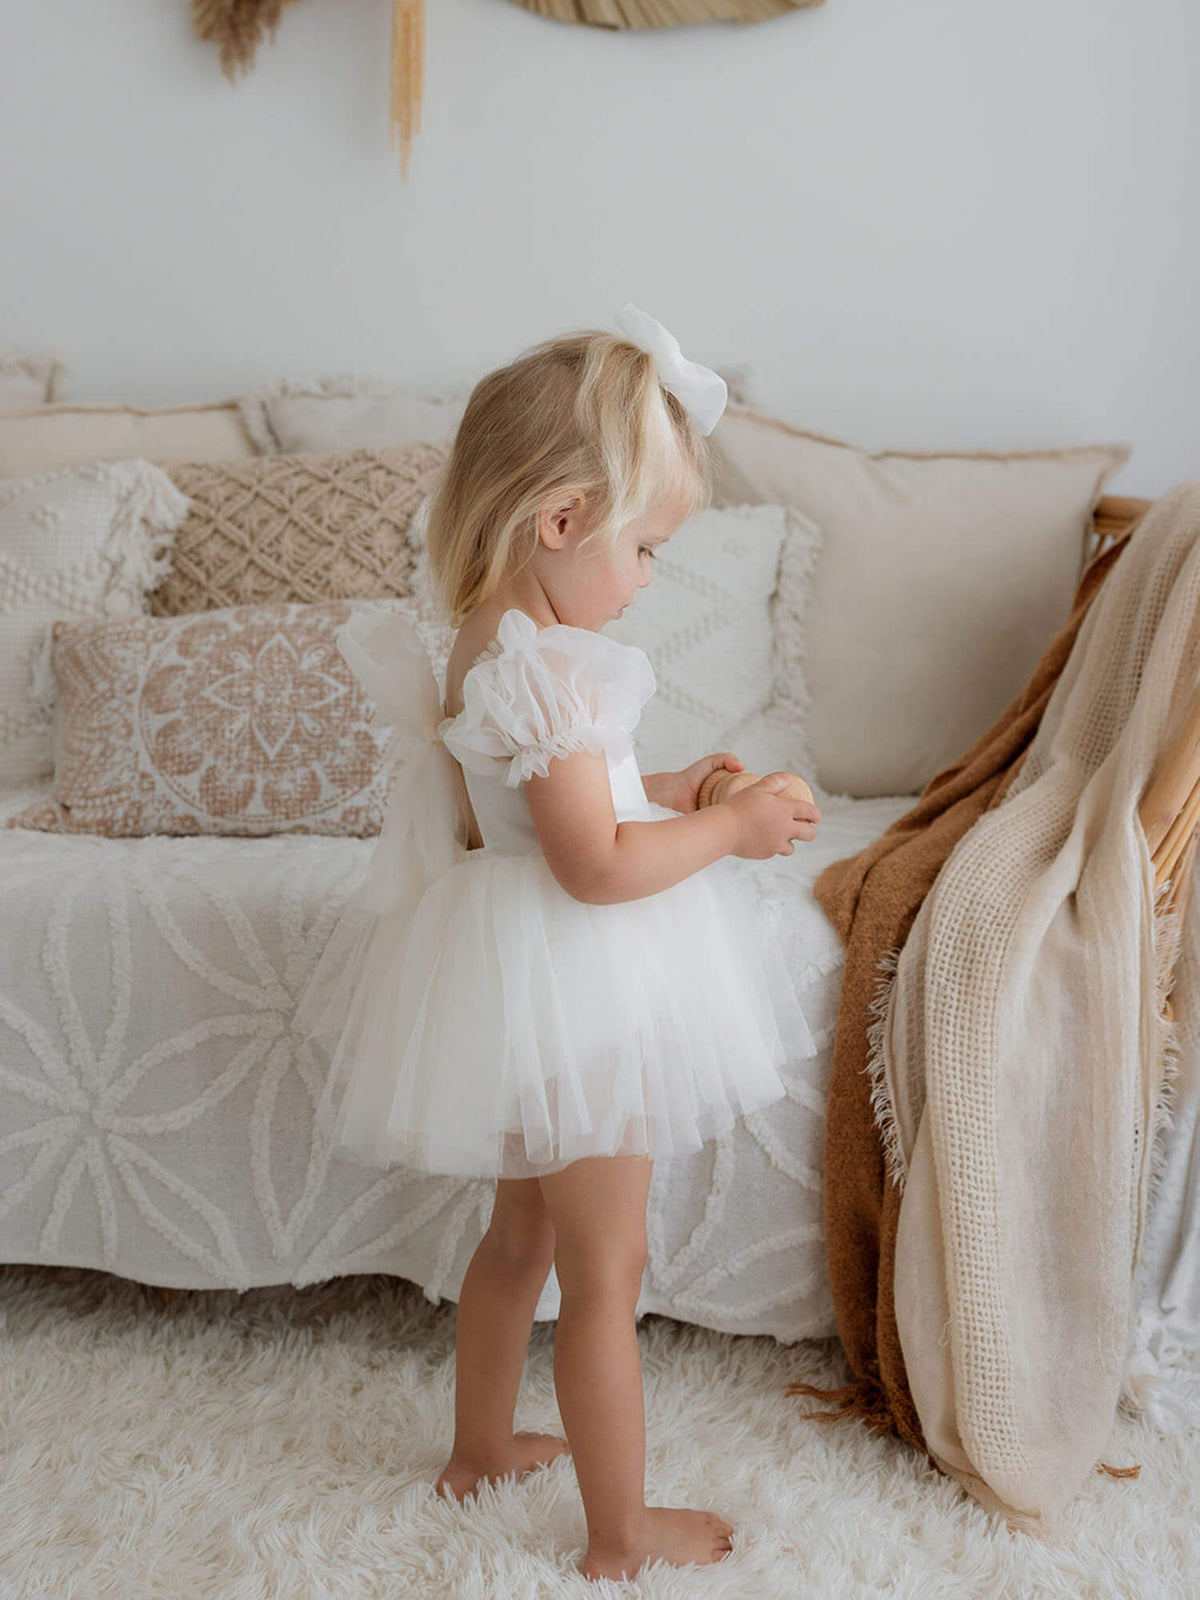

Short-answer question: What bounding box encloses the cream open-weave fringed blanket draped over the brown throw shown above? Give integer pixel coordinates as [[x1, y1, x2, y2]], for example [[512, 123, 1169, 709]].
[[869, 478, 1200, 1533]]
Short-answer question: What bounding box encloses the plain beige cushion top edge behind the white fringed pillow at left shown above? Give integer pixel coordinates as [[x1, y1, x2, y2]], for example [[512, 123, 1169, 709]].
[[0, 400, 254, 478]]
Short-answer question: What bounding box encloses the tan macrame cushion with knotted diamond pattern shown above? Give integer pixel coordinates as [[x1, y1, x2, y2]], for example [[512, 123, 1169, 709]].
[[150, 445, 445, 616]]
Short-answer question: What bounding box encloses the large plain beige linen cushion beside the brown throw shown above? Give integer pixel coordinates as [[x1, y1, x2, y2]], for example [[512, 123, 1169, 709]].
[[712, 405, 1130, 797]]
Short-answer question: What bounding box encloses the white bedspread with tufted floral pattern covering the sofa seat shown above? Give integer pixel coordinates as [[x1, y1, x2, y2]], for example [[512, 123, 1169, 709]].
[[0, 790, 912, 1341]]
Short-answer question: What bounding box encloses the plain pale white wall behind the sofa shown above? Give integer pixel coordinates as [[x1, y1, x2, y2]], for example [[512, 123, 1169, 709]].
[[0, 0, 1200, 496]]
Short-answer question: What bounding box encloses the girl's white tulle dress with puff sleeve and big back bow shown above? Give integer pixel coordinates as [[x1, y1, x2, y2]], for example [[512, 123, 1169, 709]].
[[296, 610, 816, 1178]]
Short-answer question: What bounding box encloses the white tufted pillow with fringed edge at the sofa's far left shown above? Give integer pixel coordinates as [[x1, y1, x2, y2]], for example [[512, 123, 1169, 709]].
[[0, 461, 190, 787]]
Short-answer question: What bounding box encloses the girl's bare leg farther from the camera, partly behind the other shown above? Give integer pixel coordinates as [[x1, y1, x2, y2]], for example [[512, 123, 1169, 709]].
[[437, 1178, 566, 1501]]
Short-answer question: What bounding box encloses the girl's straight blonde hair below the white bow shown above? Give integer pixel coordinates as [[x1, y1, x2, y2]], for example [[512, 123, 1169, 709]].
[[426, 328, 712, 626]]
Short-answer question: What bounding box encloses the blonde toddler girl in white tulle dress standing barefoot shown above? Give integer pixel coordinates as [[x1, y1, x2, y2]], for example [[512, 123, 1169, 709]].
[[298, 306, 821, 1578]]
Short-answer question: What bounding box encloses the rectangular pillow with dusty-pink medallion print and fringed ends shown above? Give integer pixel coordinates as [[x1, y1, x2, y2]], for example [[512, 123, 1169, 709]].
[[6, 600, 422, 837]]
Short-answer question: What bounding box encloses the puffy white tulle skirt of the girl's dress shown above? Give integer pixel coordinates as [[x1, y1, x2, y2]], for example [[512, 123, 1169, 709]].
[[296, 846, 816, 1178]]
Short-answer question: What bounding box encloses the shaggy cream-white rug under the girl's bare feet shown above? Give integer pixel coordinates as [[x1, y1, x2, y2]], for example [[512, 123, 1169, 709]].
[[0, 1266, 1200, 1600]]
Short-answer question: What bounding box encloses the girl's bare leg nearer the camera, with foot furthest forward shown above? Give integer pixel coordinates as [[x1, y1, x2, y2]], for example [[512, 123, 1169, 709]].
[[539, 1155, 733, 1578]]
